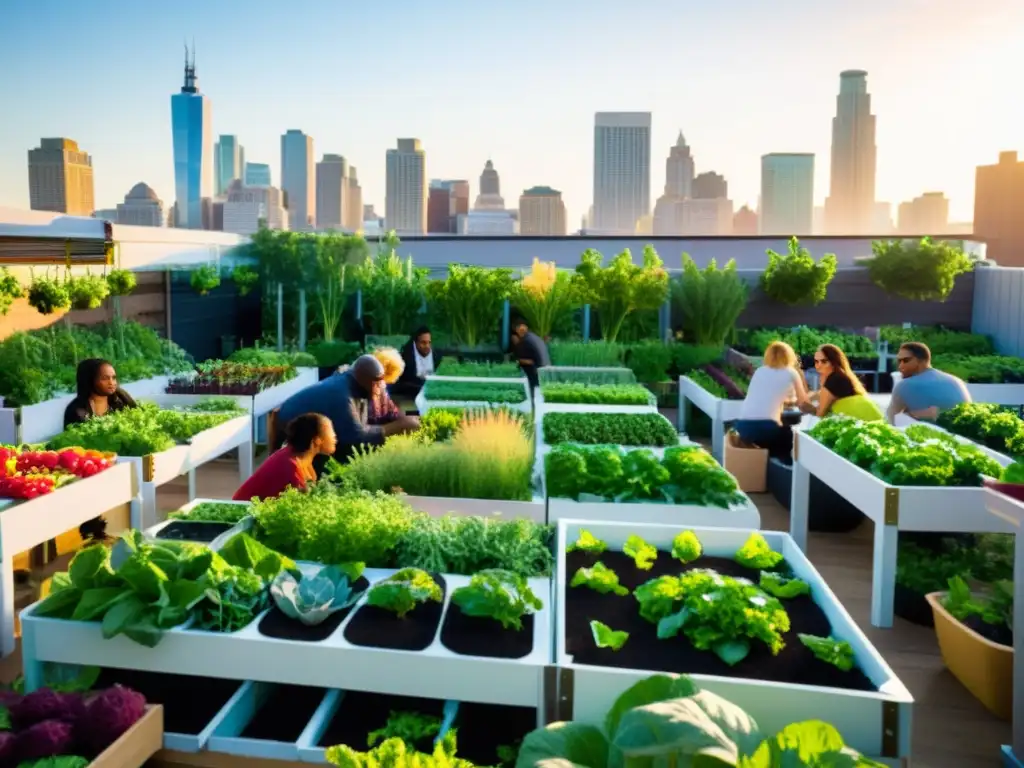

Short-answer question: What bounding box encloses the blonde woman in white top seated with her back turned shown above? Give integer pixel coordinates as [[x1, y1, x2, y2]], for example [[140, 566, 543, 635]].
[[733, 341, 808, 457]]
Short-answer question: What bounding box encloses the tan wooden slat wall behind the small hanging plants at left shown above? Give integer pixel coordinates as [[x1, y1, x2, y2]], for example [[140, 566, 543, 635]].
[[0, 272, 167, 339]]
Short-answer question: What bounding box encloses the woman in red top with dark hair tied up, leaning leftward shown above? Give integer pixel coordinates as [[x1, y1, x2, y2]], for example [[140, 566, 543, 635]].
[[231, 414, 338, 502]]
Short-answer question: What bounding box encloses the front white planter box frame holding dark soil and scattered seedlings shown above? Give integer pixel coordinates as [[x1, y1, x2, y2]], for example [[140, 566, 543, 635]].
[[555, 520, 913, 760]]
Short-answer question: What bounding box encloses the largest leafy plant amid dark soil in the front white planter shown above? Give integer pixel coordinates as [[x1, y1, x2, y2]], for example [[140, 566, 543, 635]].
[[633, 569, 790, 666]]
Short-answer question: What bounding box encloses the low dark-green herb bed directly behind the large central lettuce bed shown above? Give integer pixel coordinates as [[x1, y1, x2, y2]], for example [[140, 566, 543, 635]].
[[544, 413, 679, 446]]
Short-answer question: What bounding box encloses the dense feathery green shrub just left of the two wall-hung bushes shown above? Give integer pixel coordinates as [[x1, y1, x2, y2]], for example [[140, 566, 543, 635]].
[[672, 253, 749, 347]]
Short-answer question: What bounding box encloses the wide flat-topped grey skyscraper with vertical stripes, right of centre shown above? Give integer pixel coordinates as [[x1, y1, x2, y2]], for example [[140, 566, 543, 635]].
[[591, 112, 650, 234]]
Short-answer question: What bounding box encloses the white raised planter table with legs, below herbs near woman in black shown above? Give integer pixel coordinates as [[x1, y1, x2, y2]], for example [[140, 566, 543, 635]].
[[123, 414, 253, 528]]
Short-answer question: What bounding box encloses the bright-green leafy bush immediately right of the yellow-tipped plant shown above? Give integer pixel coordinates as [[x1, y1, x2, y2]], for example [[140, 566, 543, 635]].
[[572, 246, 669, 341]]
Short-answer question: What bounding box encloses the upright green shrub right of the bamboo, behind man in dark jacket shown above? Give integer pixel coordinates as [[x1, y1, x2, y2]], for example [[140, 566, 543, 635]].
[[355, 231, 427, 335]]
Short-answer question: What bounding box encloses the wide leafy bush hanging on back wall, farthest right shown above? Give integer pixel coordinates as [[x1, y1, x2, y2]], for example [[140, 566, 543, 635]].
[[866, 238, 975, 301]]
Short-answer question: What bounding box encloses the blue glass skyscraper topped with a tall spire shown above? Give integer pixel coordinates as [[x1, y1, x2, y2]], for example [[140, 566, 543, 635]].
[[171, 48, 213, 229]]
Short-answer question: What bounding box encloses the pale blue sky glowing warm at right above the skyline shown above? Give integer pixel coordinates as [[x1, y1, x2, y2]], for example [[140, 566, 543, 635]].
[[0, 0, 1024, 229]]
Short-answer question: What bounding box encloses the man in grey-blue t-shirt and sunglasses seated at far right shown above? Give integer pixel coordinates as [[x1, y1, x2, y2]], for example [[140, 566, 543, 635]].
[[887, 341, 971, 424]]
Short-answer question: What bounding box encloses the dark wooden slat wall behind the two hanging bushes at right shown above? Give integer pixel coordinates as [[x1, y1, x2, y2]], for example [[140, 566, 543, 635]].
[[739, 268, 974, 331]]
